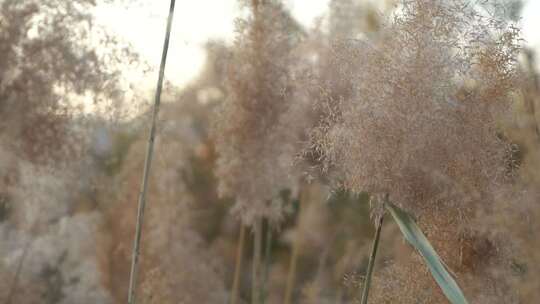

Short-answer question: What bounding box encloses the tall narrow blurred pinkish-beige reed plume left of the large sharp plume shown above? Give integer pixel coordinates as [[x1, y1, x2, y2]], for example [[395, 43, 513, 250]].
[[214, 0, 297, 224]]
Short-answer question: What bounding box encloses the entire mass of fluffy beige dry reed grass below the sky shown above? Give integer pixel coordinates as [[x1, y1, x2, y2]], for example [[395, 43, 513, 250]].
[[0, 0, 540, 304]]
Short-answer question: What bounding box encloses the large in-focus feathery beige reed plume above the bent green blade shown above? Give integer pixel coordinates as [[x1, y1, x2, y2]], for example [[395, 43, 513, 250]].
[[306, 0, 520, 303]]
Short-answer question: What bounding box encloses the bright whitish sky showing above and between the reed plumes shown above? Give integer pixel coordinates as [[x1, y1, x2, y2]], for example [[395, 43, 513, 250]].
[[97, 0, 540, 89]]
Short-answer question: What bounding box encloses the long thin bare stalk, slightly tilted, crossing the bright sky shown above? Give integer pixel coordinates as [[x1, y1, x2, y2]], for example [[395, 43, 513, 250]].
[[128, 0, 176, 304]]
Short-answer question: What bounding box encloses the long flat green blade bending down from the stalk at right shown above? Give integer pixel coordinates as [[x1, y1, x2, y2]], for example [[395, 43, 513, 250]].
[[386, 202, 468, 304]]
